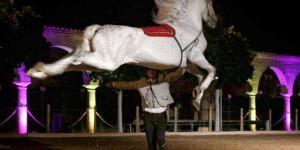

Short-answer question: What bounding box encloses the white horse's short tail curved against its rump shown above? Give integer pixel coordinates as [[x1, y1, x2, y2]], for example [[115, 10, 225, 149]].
[[82, 24, 101, 52]]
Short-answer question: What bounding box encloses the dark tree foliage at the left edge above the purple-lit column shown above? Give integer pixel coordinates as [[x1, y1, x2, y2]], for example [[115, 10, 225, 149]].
[[0, 1, 50, 67]]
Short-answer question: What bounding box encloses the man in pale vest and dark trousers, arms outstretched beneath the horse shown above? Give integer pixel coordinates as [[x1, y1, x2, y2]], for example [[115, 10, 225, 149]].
[[106, 68, 185, 150]]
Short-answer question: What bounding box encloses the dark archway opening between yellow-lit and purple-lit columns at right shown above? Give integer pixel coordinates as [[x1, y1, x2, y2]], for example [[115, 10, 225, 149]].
[[256, 66, 286, 130]]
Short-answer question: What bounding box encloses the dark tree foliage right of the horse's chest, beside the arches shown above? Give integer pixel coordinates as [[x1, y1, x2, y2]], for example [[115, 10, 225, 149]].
[[205, 25, 255, 87]]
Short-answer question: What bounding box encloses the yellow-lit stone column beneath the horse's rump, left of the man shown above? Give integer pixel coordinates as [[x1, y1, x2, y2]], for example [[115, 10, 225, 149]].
[[83, 81, 99, 133]]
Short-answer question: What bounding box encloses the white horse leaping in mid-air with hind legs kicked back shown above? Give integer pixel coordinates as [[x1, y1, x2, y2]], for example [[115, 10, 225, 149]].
[[27, 0, 217, 110]]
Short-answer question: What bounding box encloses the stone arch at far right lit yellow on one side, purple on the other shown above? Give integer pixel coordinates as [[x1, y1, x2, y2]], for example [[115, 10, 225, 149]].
[[248, 52, 300, 130]]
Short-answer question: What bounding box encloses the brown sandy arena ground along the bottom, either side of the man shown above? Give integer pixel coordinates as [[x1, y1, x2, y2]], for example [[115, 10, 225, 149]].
[[0, 131, 300, 150]]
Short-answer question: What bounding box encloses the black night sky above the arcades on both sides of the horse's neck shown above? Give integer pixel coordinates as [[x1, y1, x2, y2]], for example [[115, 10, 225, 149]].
[[15, 0, 300, 55]]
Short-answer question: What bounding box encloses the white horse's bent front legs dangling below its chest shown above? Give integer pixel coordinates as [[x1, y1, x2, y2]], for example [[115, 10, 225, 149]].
[[189, 53, 216, 110]]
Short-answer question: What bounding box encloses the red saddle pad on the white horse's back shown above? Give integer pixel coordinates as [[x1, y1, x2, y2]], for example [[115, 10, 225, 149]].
[[142, 24, 175, 37]]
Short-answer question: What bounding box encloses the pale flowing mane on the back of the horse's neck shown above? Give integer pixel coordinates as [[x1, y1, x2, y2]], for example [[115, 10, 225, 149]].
[[152, 0, 186, 24]]
